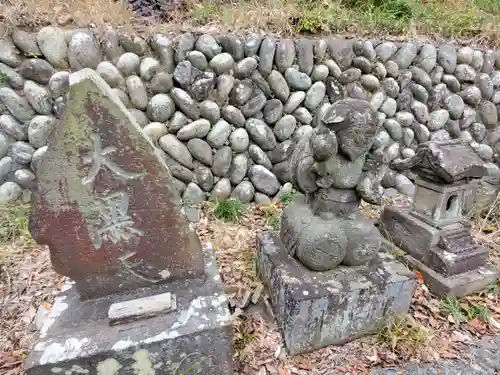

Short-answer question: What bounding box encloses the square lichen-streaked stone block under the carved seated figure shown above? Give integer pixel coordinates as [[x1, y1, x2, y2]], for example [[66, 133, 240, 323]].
[[257, 231, 416, 355]]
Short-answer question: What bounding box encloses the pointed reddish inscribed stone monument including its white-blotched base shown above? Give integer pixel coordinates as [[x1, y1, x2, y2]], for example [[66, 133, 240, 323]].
[[25, 69, 233, 375]]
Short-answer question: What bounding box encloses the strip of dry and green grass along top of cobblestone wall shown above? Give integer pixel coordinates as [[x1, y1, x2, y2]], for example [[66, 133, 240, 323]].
[[0, 0, 500, 46]]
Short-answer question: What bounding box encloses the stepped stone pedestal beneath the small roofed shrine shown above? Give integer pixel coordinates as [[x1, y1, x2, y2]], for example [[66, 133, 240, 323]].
[[380, 207, 499, 297]]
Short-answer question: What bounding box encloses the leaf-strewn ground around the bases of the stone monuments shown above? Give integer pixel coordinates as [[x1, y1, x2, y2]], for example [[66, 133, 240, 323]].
[[0, 198, 500, 375]]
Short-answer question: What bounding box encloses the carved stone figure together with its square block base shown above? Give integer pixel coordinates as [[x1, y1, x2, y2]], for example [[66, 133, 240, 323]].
[[257, 99, 416, 355]]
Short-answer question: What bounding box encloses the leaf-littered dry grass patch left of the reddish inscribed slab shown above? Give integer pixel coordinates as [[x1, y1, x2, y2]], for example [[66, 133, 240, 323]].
[[0, 203, 62, 375]]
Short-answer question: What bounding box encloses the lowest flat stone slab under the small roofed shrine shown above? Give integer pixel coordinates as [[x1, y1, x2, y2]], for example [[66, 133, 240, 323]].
[[405, 255, 500, 297]]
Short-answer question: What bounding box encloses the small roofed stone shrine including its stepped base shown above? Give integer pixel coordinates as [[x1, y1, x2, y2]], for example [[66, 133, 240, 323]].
[[380, 140, 498, 296]]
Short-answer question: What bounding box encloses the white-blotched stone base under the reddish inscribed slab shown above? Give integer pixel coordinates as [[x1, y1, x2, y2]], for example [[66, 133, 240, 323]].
[[25, 248, 233, 375]]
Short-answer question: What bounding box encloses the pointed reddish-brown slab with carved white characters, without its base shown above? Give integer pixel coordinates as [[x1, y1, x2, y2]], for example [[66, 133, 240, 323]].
[[30, 69, 204, 299]]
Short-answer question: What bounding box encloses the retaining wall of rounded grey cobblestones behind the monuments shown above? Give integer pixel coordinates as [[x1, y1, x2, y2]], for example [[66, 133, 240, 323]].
[[0, 26, 500, 203]]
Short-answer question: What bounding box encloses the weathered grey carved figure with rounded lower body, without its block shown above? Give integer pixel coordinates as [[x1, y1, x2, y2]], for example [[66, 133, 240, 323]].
[[280, 99, 388, 271]]
